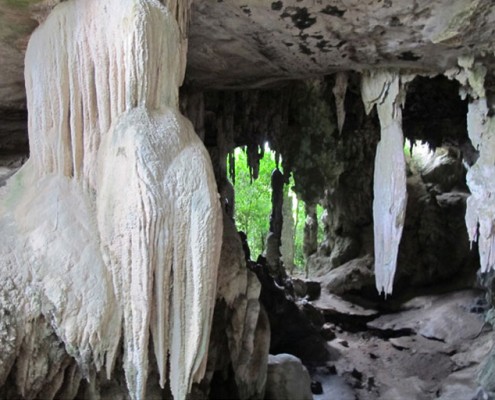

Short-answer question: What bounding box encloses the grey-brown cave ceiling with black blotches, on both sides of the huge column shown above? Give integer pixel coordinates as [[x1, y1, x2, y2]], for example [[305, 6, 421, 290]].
[[0, 0, 495, 110]]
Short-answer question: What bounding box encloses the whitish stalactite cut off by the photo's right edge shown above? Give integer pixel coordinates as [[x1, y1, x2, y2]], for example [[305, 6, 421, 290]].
[[456, 57, 495, 272]]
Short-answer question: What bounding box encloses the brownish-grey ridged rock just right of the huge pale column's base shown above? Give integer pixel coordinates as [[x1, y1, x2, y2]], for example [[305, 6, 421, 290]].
[[206, 214, 270, 399]]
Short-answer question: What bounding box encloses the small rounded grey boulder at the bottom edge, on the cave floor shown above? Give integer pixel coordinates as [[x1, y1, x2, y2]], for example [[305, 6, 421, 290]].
[[266, 353, 313, 400]]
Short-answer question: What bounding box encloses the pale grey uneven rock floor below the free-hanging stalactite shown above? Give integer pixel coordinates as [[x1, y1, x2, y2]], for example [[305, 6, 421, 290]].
[[310, 290, 493, 400]]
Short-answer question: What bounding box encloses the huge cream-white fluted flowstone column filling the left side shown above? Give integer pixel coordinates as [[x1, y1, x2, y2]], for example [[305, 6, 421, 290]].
[[0, 0, 222, 400]]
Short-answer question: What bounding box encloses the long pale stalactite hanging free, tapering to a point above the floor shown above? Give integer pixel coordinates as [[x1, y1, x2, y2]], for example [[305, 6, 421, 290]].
[[362, 71, 407, 295]]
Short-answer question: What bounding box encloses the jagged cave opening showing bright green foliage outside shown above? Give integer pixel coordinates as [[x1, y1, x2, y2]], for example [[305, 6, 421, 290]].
[[225, 143, 324, 278]]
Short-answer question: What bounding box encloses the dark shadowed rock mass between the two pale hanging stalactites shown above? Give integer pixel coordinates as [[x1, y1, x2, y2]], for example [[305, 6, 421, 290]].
[[395, 173, 476, 292]]
